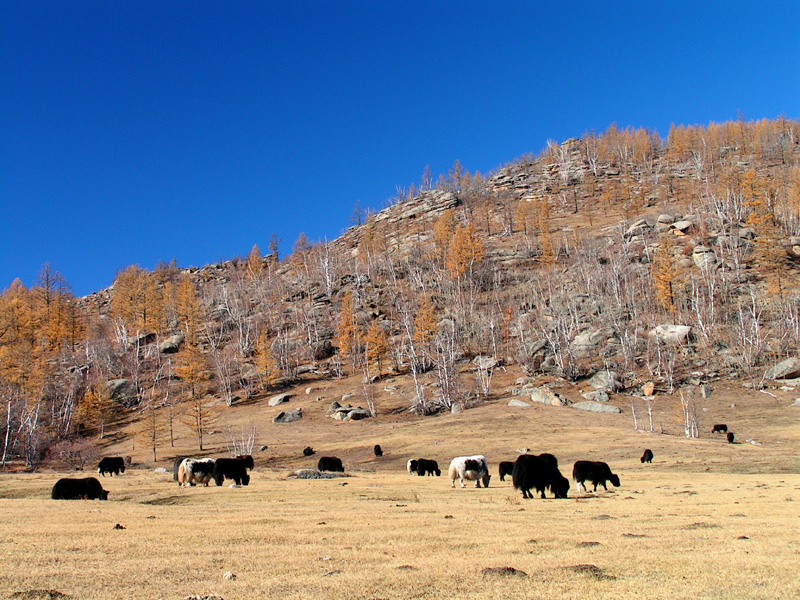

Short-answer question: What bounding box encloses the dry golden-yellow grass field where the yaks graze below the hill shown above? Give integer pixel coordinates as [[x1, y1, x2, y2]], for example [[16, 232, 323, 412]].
[[0, 376, 800, 600]]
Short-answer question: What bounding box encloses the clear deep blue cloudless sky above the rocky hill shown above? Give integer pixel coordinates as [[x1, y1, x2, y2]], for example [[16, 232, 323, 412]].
[[0, 0, 800, 295]]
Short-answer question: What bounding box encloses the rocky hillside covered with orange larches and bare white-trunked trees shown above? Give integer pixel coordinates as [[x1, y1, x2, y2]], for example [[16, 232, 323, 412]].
[[0, 118, 800, 470]]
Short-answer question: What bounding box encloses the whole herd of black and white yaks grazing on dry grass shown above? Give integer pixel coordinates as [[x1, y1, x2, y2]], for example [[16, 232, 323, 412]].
[[51, 425, 733, 500]]
